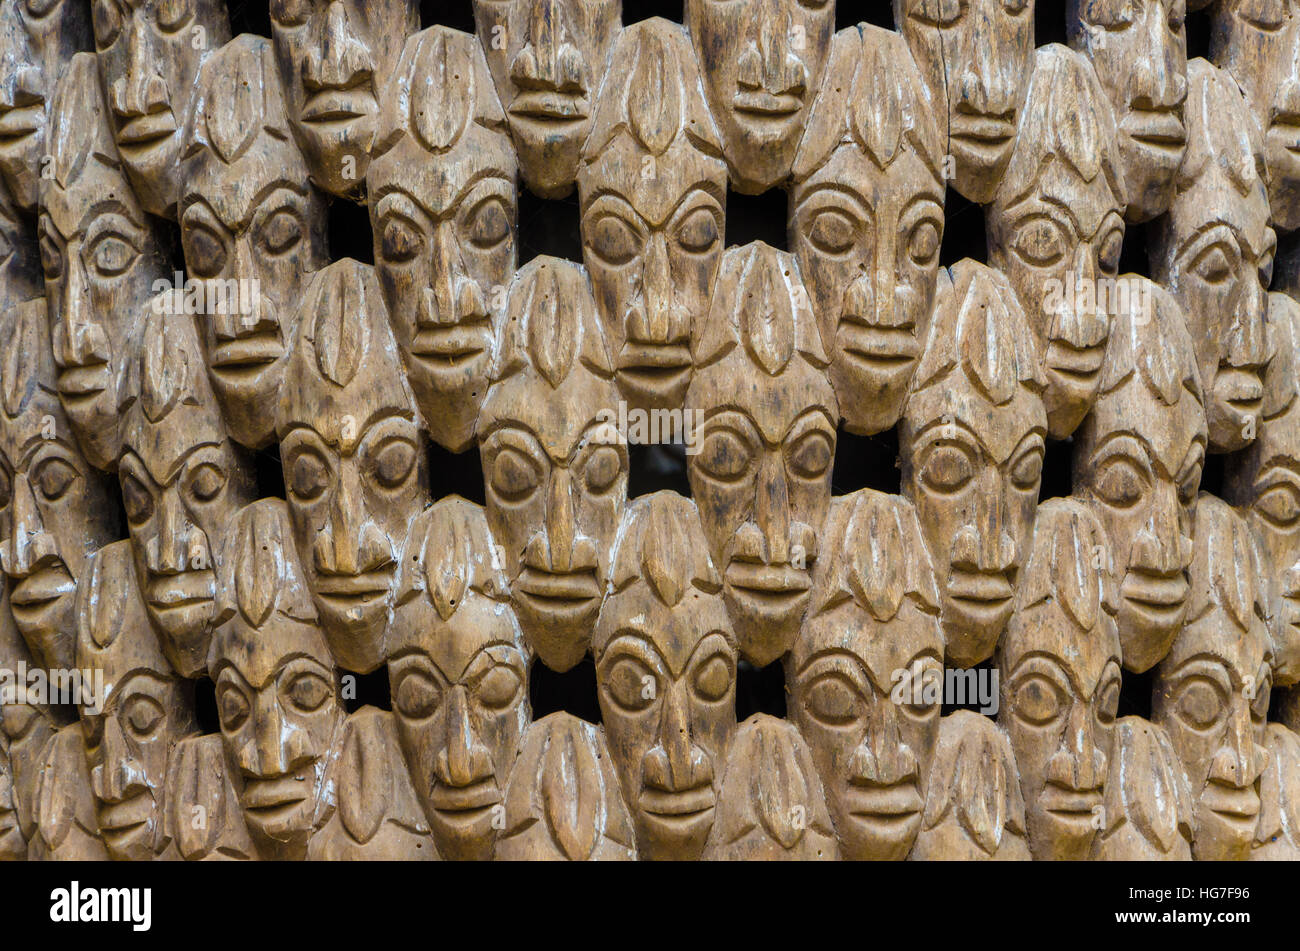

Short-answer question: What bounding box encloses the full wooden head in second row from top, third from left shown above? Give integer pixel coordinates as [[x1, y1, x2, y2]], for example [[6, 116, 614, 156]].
[[367, 26, 519, 452]]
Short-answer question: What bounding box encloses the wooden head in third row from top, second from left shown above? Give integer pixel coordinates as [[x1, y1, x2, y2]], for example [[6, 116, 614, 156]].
[[117, 292, 255, 677]]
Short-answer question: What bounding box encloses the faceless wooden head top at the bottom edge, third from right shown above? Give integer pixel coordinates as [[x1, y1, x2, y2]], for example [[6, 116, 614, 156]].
[[910, 709, 1030, 861]]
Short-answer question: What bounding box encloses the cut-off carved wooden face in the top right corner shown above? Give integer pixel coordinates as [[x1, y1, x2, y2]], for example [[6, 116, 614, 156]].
[[1212, 0, 1300, 231]]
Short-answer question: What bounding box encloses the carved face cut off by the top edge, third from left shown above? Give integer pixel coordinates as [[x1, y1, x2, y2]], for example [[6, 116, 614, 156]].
[[270, 0, 419, 196]]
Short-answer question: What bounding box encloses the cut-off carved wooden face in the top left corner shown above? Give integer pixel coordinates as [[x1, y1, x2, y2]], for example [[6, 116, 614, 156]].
[[0, 0, 91, 214]]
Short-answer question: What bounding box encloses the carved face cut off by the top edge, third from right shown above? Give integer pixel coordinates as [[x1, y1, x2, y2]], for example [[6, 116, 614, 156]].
[[893, 0, 1034, 203]]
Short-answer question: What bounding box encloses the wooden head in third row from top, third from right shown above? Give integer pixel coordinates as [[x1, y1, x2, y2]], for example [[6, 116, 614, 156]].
[[898, 260, 1047, 666]]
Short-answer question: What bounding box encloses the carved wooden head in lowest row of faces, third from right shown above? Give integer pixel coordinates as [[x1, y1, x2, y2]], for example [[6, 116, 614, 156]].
[[785, 490, 944, 860]]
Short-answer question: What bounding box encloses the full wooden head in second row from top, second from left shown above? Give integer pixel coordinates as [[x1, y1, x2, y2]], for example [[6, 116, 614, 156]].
[[185, 34, 329, 448]]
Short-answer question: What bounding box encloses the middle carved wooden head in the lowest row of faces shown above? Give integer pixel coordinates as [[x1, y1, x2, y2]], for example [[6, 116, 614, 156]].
[[592, 492, 737, 860]]
